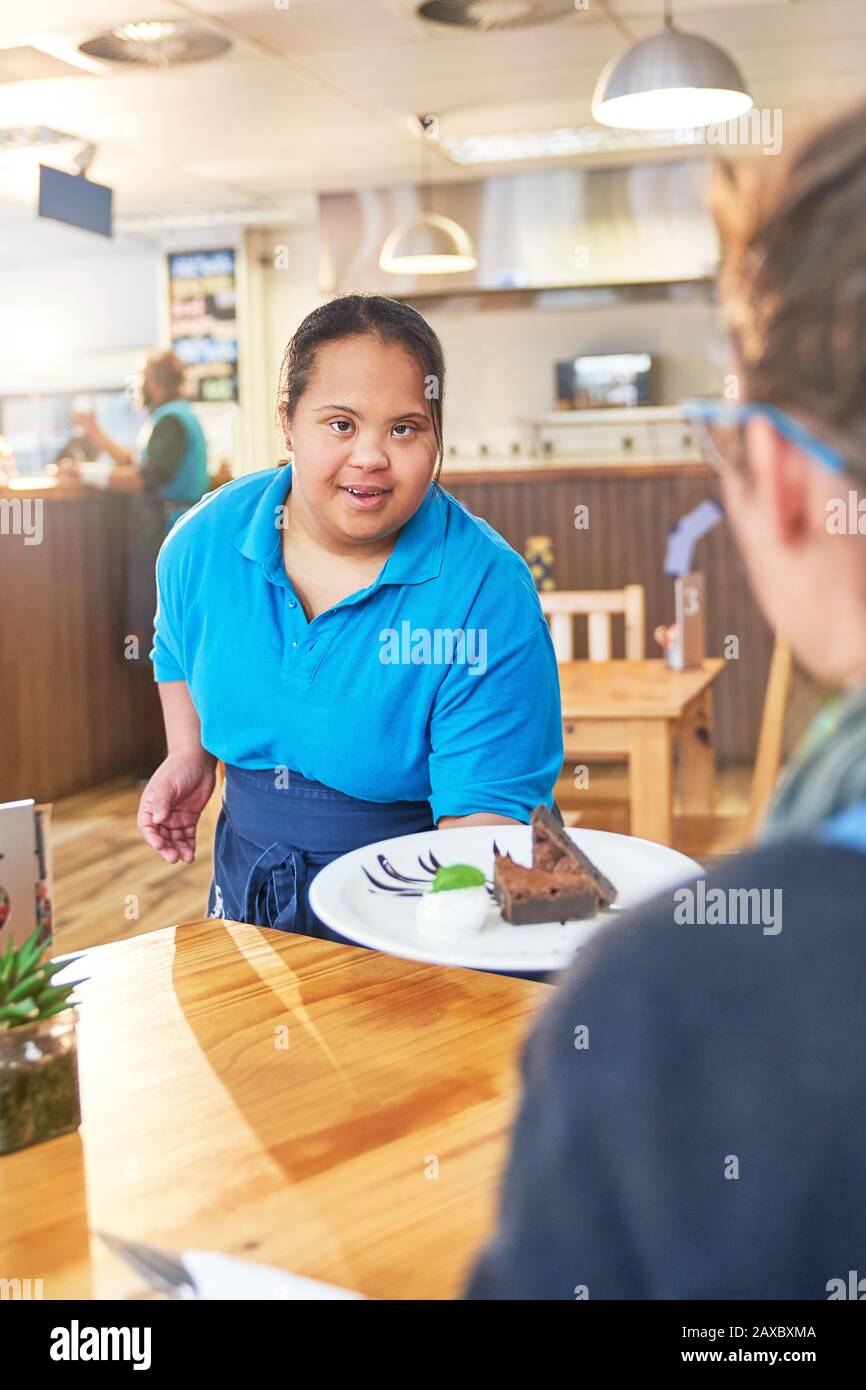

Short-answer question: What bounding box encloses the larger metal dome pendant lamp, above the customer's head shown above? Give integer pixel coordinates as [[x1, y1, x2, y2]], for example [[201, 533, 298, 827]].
[[592, 25, 752, 131]]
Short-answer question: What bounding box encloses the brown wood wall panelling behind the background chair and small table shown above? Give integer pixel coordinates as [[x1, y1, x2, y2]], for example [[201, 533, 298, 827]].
[[443, 466, 773, 763]]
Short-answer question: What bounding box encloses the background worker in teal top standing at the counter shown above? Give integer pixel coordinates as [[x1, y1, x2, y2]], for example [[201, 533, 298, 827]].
[[74, 352, 209, 670]]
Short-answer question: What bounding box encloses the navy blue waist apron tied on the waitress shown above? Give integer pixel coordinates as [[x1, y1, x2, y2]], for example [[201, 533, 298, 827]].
[[207, 766, 435, 944]]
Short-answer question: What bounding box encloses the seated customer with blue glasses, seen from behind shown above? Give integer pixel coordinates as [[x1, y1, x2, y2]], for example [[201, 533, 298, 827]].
[[467, 106, 866, 1300]]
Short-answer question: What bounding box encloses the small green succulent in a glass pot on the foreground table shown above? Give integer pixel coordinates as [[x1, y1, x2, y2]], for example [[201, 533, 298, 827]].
[[0, 923, 81, 1154]]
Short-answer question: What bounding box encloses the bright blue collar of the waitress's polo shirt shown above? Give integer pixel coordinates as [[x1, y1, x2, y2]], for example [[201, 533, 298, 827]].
[[234, 464, 446, 588]]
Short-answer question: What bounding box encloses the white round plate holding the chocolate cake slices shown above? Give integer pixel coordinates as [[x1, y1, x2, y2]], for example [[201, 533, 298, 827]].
[[310, 826, 701, 972]]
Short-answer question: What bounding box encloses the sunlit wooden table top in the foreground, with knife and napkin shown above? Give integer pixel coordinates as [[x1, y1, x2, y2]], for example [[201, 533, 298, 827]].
[[0, 920, 550, 1300]]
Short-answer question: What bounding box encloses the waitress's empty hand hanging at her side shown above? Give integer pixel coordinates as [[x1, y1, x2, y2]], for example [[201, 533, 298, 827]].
[[138, 749, 215, 865]]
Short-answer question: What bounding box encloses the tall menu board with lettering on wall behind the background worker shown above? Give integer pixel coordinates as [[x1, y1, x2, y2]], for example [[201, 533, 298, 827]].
[[168, 247, 238, 400]]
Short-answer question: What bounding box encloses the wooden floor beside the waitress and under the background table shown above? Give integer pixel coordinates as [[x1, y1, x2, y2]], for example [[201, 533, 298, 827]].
[[51, 765, 751, 951]]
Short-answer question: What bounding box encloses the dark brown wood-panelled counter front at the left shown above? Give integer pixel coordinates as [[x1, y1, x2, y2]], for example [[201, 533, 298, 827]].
[[0, 492, 163, 801]]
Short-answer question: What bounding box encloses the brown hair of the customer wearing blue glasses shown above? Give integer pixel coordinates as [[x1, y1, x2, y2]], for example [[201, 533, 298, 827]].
[[712, 104, 866, 474]]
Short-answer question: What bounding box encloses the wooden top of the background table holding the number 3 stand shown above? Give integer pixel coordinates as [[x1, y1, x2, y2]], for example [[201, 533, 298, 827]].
[[559, 657, 727, 719]]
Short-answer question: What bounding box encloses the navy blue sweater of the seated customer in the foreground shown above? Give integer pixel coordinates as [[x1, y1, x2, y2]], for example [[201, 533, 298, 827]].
[[466, 840, 866, 1300]]
